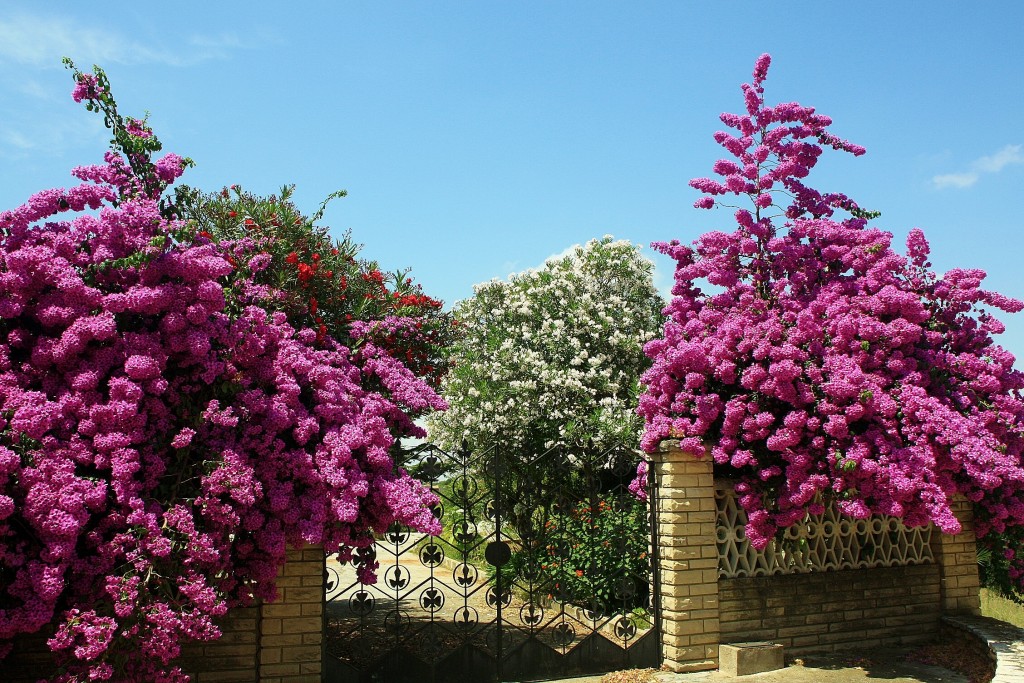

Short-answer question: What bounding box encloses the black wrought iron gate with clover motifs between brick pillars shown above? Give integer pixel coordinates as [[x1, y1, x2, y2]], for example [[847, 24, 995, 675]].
[[325, 444, 659, 683]]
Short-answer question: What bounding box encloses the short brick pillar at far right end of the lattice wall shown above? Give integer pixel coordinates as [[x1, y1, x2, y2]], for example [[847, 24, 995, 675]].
[[932, 496, 981, 614]]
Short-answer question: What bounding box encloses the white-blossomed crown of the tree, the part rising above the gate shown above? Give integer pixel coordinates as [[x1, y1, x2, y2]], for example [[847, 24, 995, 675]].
[[429, 237, 664, 456]]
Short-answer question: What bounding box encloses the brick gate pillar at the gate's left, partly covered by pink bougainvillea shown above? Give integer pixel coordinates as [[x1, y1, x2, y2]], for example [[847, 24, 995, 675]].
[[259, 546, 325, 683]]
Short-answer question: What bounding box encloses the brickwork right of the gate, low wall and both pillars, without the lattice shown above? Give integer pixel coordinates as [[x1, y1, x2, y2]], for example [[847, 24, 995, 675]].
[[652, 441, 979, 671]]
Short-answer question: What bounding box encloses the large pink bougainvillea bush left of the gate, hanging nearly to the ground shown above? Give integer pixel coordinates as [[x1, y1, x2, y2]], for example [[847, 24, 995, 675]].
[[0, 62, 443, 681]]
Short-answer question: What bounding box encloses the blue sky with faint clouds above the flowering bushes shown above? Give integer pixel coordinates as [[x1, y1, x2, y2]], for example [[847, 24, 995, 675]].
[[6, 0, 1024, 368]]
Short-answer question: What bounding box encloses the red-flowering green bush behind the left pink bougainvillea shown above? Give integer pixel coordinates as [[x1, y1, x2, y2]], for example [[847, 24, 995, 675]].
[[180, 185, 453, 386]]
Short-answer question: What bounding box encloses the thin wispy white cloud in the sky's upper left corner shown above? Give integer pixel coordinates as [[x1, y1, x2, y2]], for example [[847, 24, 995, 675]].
[[0, 13, 268, 68]]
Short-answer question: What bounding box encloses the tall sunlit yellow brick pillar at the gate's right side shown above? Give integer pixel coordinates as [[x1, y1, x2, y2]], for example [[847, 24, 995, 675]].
[[653, 441, 720, 672]]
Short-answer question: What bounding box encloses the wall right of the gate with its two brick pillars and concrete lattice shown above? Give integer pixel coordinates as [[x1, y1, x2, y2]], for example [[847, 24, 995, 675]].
[[652, 442, 979, 671]]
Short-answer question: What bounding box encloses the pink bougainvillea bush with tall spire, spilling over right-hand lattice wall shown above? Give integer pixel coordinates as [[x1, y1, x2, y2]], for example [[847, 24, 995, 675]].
[[639, 55, 1024, 589]]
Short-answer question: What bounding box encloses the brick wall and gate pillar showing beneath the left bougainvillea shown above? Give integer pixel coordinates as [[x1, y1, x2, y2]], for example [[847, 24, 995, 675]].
[[0, 546, 324, 683]]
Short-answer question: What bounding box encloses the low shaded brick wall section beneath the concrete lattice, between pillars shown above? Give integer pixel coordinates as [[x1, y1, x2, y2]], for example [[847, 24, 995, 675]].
[[719, 564, 941, 655]]
